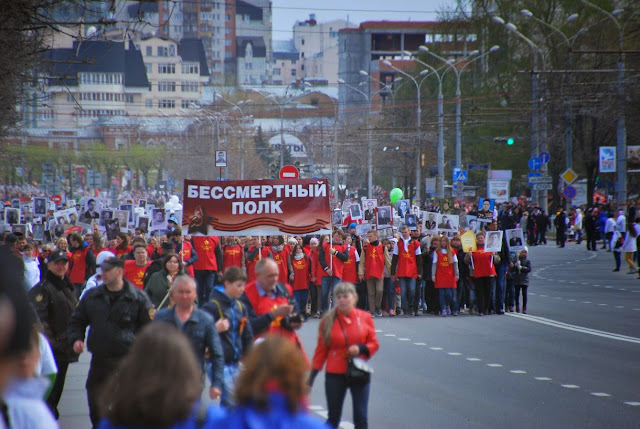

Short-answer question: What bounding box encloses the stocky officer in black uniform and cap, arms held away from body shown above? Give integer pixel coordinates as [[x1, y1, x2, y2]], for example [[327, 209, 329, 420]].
[[69, 257, 154, 428]]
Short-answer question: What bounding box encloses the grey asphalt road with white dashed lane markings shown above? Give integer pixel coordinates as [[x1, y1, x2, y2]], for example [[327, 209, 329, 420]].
[[60, 243, 640, 429]]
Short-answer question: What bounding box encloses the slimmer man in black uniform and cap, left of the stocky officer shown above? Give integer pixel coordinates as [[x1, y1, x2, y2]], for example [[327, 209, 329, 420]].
[[29, 250, 78, 419]]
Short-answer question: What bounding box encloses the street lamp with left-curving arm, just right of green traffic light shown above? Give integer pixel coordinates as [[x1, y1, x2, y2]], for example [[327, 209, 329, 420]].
[[493, 16, 547, 211]]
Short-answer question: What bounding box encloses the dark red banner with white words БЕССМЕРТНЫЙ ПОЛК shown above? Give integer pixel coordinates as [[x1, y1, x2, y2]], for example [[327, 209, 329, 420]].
[[182, 179, 331, 235]]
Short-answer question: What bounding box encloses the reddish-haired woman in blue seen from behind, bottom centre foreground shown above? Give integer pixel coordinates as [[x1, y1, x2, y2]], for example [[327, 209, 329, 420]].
[[206, 335, 326, 429]]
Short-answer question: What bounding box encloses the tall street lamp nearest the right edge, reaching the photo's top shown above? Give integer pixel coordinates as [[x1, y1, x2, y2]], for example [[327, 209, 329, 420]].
[[582, 0, 627, 207]]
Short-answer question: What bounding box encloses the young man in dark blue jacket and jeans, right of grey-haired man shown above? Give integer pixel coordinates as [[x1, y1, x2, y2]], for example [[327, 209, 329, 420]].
[[202, 267, 253, 407]]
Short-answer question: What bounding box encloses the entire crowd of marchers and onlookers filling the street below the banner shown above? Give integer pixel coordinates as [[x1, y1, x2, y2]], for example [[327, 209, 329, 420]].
[[0, 185, 640, 428]]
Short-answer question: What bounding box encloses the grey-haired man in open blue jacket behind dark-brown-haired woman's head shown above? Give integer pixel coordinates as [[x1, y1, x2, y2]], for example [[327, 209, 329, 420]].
[[154, 275, 224, 399]]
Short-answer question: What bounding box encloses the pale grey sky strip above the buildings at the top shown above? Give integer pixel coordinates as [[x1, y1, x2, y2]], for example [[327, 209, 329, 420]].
[[272, 0, 457, 40]]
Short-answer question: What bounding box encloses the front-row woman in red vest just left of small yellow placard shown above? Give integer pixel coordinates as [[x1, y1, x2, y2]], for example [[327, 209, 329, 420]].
[[431, 235, 460, 316]]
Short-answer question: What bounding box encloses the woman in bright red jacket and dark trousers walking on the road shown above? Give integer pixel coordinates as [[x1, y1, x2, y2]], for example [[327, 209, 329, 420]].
[[309, 283, 380, 428]]
